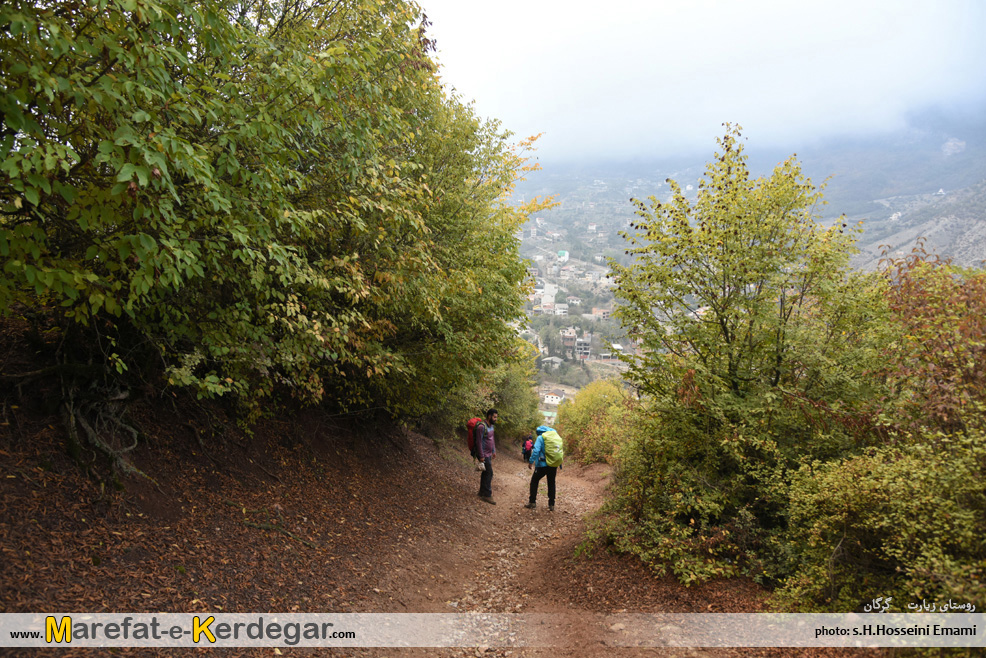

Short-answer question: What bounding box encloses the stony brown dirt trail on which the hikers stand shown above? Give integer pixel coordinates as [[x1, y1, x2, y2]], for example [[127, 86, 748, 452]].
[[345, 434, 749, 658]]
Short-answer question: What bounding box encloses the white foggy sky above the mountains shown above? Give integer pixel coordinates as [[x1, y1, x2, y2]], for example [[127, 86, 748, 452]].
[[419, 0, 986, 161]]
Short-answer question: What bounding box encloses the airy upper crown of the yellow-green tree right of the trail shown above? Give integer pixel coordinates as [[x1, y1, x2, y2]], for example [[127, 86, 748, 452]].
[[611, 128, 872, 404]]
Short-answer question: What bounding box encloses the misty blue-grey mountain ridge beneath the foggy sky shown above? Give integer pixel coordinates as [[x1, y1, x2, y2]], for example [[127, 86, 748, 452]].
[[518, 110, 986, 269]]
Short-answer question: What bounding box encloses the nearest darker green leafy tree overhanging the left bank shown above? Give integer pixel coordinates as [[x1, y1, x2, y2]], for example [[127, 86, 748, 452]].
[[0, 1, 424, 398]]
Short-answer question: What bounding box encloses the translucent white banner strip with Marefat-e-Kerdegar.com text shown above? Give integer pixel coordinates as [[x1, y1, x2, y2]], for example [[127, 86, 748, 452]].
[[0, 612, 986, 648]]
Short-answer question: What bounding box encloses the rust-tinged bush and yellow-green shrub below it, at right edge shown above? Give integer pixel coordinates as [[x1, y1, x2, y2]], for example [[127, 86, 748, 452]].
[[780, 248, 986, 609]]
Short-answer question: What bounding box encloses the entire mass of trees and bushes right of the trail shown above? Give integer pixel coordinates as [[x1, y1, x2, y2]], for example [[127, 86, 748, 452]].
[[558, 128, 986, 611]]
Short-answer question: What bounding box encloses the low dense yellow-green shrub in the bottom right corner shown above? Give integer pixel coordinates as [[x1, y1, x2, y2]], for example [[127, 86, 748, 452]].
[[778, 431, 986, 612]]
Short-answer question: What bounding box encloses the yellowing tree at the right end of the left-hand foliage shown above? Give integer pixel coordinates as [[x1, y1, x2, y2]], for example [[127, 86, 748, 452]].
[[344, 121, 543, 415]]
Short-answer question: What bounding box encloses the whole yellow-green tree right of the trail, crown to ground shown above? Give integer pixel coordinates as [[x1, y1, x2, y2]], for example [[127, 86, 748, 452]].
[[611, 127, 884, 580]]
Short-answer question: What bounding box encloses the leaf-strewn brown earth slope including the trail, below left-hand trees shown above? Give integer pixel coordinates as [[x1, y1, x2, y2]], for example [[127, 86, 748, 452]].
[[0, 362, 876, 657]]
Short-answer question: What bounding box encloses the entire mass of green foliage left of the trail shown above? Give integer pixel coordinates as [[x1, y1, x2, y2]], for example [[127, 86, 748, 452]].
[[0, 0, 538, 438]]
